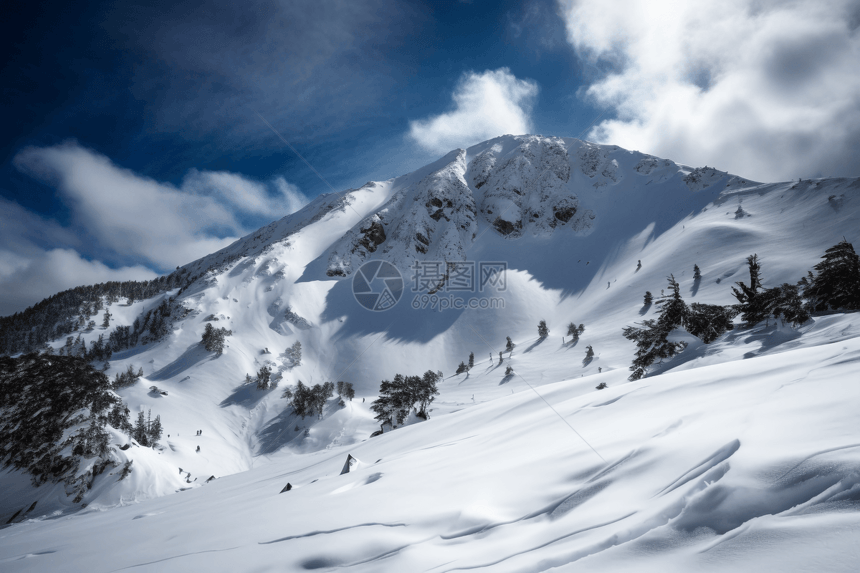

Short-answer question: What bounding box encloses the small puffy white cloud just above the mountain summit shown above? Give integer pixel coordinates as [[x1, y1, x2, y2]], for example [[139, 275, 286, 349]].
[[409, 68, 538, 153]]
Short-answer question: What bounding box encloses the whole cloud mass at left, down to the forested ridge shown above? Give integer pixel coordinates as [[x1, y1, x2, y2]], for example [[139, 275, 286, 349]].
[[0, 143, 307, 315]]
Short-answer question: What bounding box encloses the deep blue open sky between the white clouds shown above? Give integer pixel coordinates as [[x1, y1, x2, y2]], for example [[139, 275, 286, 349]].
[[0, 0, 601, 217]]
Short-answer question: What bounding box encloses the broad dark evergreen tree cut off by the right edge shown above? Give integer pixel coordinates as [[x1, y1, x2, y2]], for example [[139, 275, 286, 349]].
[[804, 239, 860, 312]]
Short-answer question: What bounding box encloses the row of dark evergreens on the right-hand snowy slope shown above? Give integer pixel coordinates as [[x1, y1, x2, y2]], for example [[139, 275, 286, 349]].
[[623, 239, 860, 380]]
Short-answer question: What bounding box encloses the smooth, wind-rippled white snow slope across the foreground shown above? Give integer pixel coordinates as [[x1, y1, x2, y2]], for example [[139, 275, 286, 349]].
[[0, 315, 860, 571]]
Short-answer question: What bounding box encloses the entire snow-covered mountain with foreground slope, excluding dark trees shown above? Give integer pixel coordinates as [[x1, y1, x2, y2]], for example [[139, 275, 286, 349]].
[[0, 136, 860, 571]]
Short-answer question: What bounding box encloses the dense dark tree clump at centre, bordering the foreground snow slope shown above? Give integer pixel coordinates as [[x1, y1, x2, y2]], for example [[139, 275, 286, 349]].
[[370, 370, 442, 427]]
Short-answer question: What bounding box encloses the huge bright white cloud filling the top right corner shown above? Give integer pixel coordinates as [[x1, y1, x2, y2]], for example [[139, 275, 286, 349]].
[[559, 0, 860, 181]]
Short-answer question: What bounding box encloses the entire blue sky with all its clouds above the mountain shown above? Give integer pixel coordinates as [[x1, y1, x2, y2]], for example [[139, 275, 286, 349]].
[[0, 0, 860, 315]]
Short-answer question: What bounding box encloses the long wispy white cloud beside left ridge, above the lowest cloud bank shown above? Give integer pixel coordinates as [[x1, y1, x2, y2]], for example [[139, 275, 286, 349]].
[[14, 143, 307, 268]]
